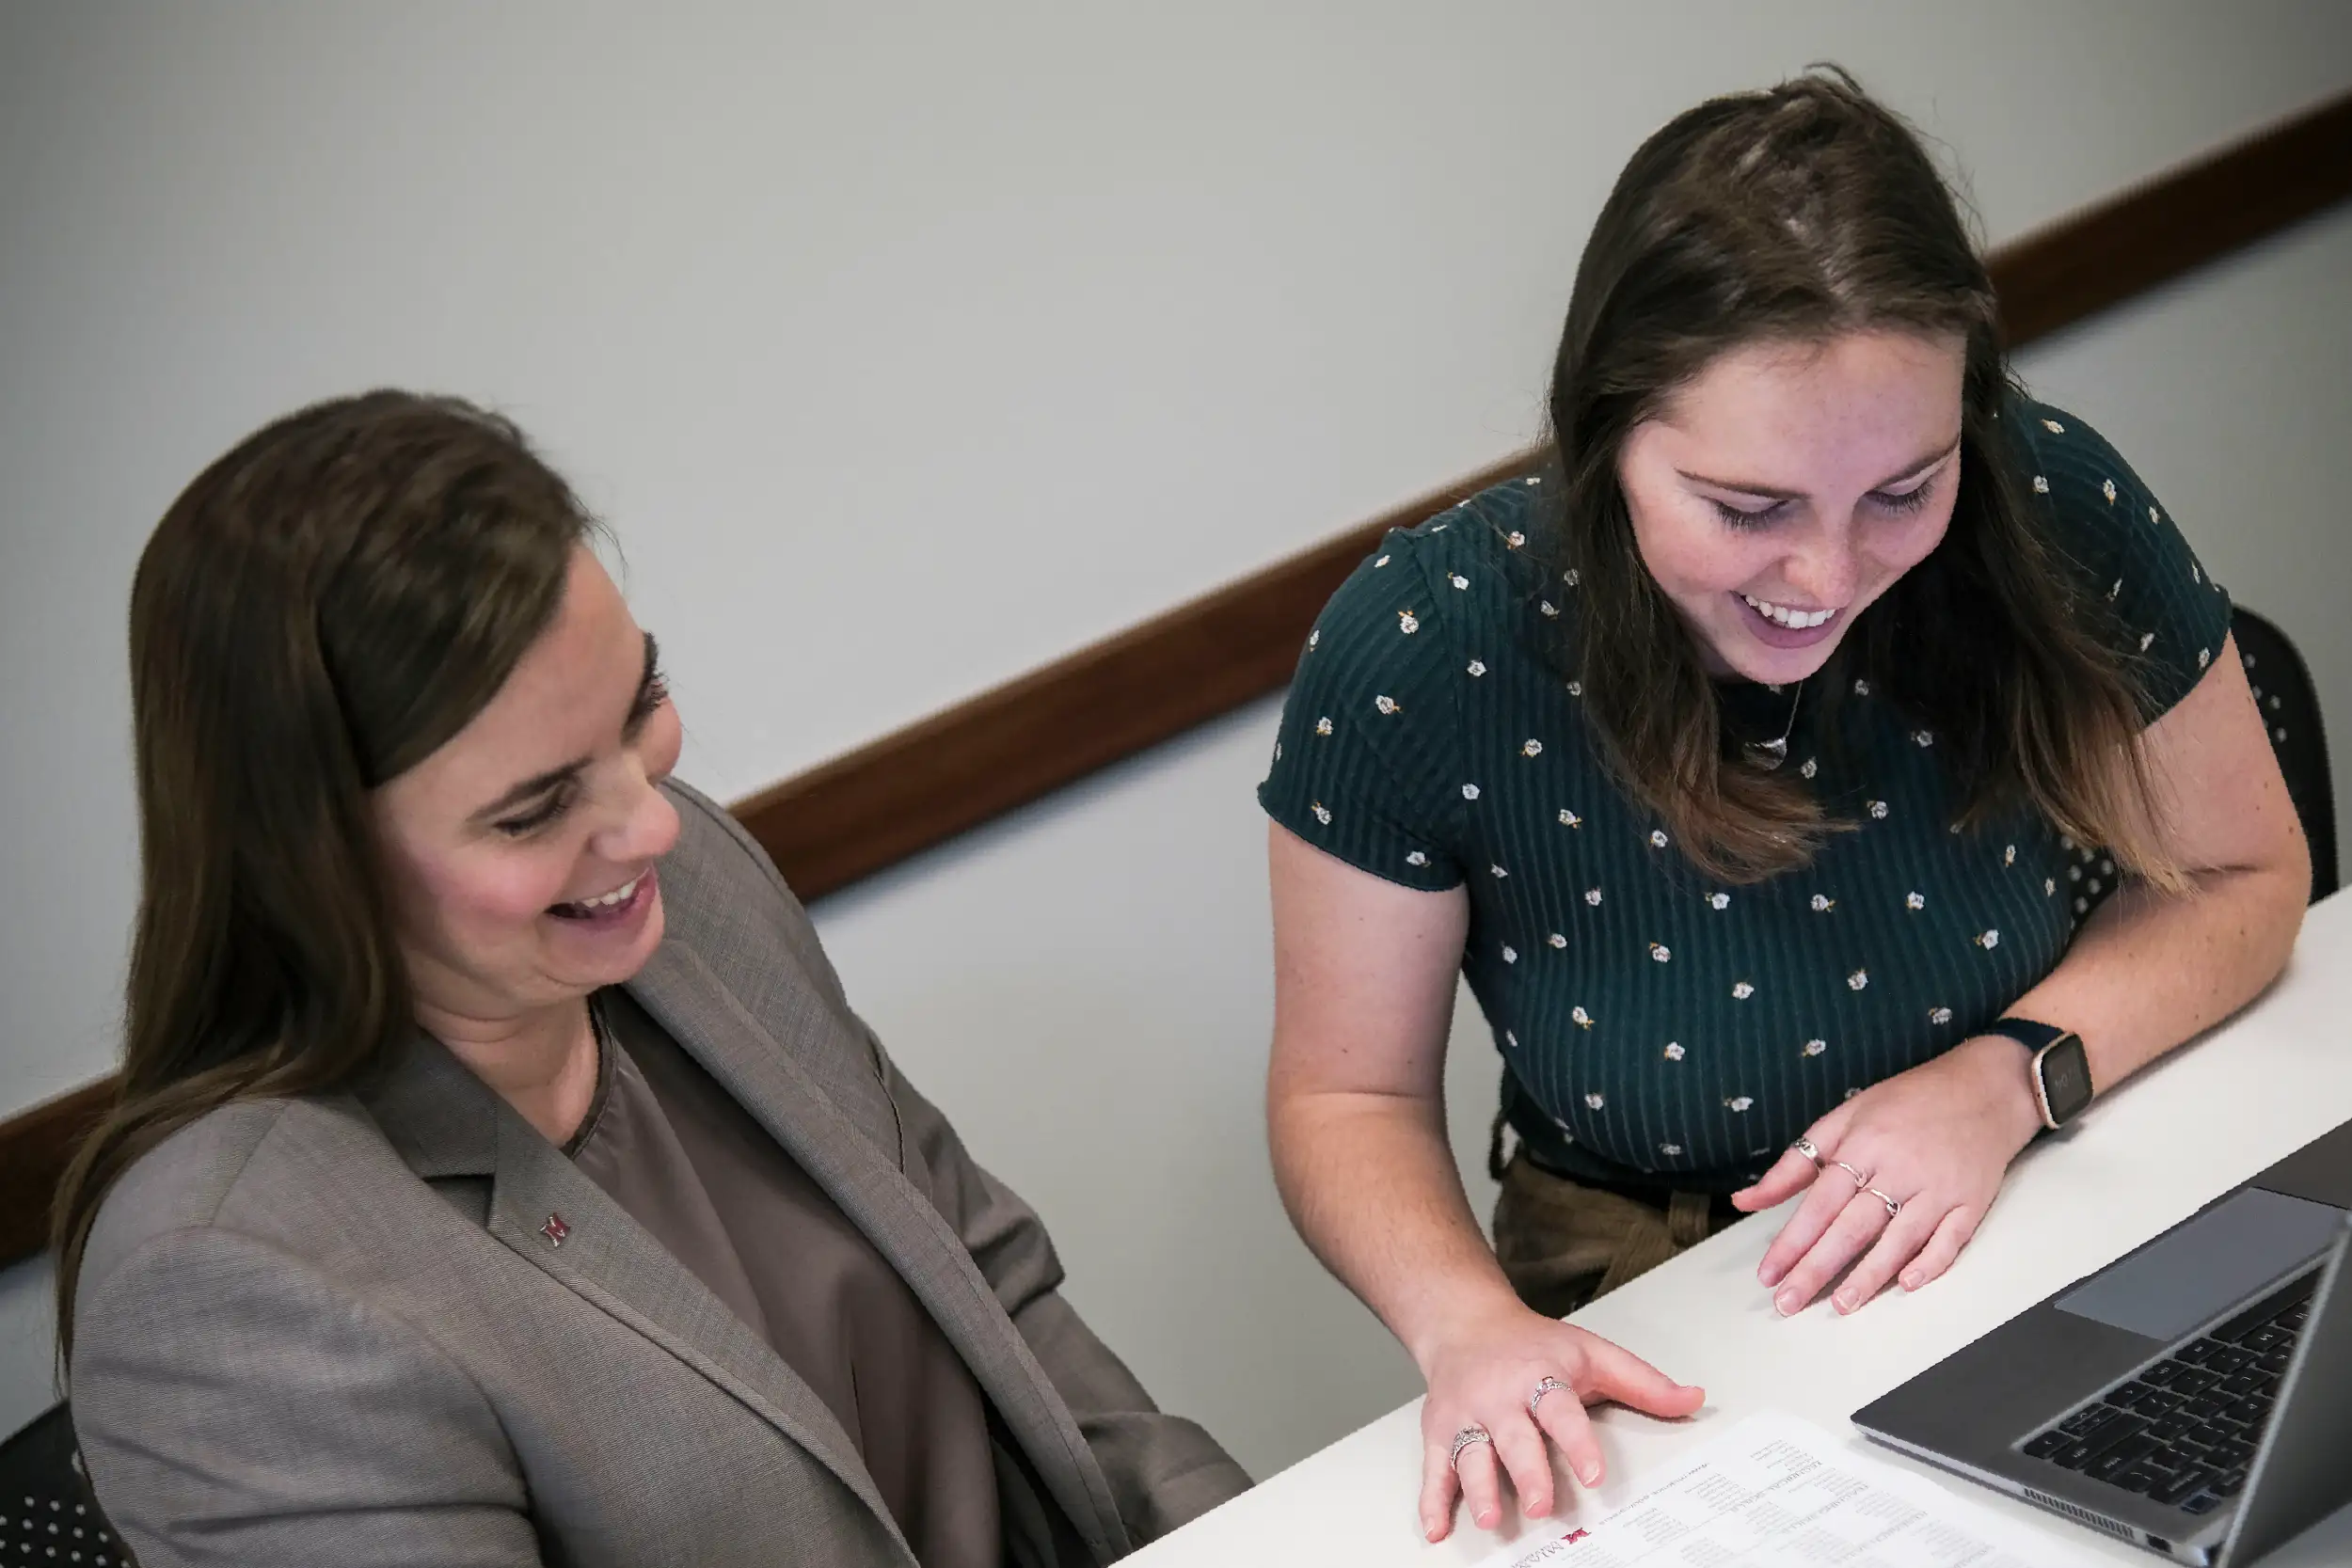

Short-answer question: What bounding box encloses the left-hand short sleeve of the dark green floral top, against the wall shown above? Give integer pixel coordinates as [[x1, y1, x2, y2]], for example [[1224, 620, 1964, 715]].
[[1259, 533, 1463, 891]]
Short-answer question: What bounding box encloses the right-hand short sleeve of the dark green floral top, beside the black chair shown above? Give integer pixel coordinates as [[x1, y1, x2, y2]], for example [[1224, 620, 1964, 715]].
[[2018, 402, 2230, 724]]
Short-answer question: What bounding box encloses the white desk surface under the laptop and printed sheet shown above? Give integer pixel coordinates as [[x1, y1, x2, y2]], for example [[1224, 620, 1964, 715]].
[[1132, 891, 2352, 1568]]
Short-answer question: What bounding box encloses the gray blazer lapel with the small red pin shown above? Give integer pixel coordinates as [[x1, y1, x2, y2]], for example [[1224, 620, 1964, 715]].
[[362, 1035, 913, 1561]]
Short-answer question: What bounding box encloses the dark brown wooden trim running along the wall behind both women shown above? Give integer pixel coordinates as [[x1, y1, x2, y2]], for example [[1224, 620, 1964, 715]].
[[0, 94, 2352, 1265]]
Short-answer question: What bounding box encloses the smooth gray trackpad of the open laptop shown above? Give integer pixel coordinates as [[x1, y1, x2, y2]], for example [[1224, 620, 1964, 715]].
[[2056, 1187, 2345, 1340]]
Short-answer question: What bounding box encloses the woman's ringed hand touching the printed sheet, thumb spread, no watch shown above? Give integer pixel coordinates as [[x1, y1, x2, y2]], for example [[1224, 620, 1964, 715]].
[[1421, 1298, 1708, 1540]]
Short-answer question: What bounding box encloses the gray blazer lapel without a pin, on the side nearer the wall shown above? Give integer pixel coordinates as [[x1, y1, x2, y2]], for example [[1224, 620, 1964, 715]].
[[628, 941, 1127, 1561]]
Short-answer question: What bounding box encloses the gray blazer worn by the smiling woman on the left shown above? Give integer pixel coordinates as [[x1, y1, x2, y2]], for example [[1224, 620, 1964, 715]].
[[71, 785, 1249, 1568]]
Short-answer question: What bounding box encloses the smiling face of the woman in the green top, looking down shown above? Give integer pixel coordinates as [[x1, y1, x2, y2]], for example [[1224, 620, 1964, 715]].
[[1618, 331, 1966, 684]]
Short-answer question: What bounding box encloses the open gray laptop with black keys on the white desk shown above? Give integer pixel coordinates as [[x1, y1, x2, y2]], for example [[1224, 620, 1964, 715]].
[[1853, 1121, 2352, 1568]]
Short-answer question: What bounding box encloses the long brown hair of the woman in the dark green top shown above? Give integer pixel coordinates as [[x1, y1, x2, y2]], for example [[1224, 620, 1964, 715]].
[[1546, 66, 2185, 889]]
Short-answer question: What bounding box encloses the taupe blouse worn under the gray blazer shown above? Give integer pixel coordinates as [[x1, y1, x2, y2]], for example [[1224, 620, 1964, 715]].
[[579, 988, 1002, 1568]]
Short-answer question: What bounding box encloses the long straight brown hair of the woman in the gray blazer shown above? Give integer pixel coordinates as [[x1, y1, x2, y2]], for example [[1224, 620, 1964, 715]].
[[55, 392, 596, 1366]]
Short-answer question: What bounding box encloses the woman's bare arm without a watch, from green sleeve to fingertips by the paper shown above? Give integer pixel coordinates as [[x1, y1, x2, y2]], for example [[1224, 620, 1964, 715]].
[[1265, 825, 1706, 1540]]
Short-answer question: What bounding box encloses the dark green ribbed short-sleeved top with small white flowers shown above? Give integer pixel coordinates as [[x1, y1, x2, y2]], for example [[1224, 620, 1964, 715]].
[[1259, 404, 2230, 1192]]
